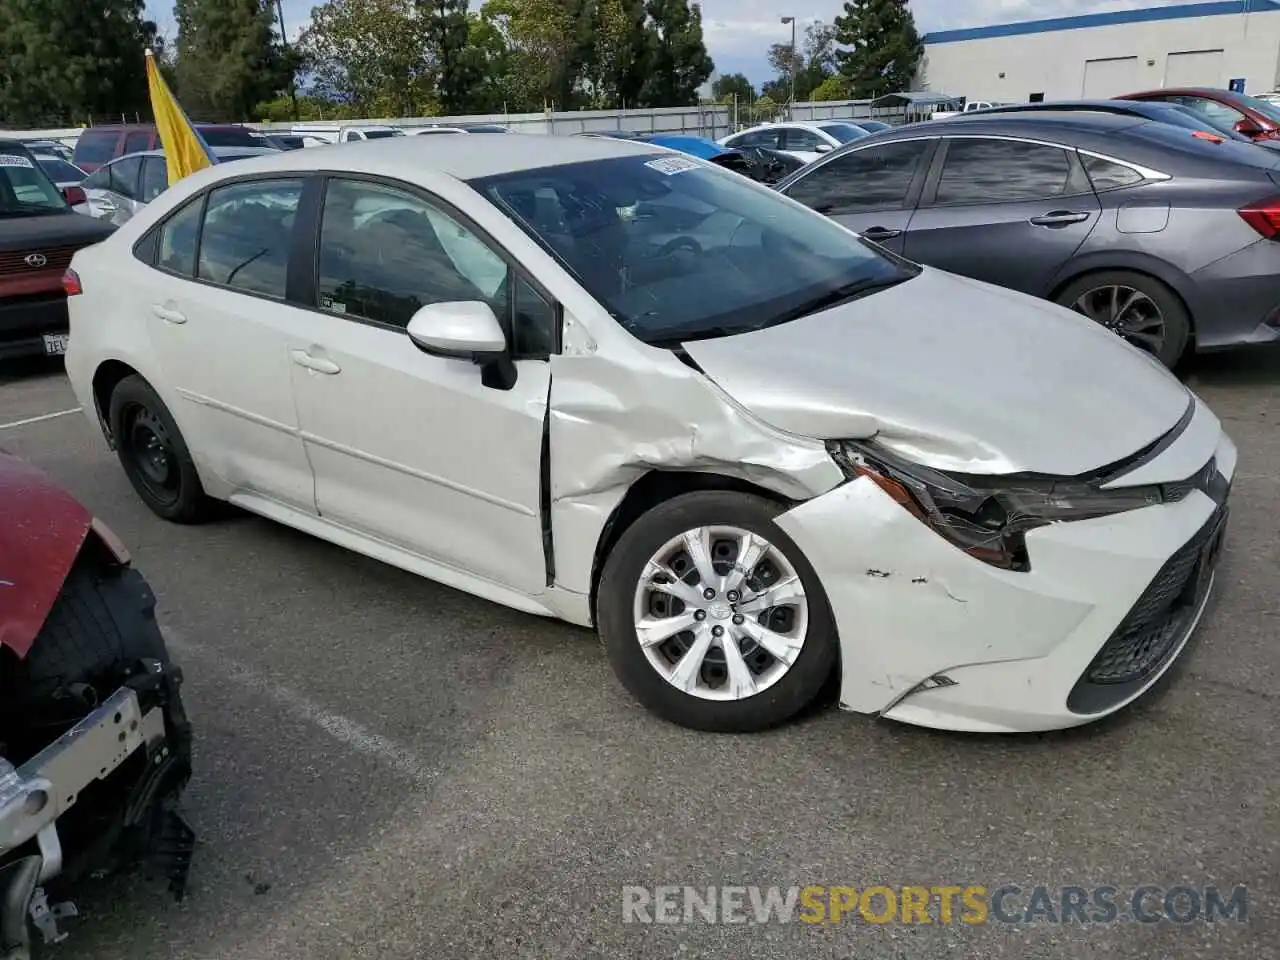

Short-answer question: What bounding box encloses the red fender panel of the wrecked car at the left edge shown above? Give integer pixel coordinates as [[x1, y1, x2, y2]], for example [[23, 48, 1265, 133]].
[[0, 453, 93, 658]]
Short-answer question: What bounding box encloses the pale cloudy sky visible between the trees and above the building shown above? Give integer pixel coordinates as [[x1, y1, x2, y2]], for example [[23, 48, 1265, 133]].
[[147, 0, 1213, 84]]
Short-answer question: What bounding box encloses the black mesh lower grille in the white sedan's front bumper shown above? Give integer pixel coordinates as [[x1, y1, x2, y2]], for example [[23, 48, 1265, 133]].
[[1068, 503, 1226, 713]]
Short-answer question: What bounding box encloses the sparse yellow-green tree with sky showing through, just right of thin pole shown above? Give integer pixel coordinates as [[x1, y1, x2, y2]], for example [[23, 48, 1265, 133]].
[[298, 0, 433, 116]]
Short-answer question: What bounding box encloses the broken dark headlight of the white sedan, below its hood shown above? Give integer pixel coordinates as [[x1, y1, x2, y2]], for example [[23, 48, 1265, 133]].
[[827, 440, 1165, 571]]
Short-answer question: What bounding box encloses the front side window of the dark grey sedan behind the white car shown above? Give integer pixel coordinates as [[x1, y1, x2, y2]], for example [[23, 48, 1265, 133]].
[[787, 140, 929, 214]]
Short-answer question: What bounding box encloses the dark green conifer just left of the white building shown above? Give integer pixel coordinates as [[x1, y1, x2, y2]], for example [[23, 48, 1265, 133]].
[[836, 0, 924, 99]]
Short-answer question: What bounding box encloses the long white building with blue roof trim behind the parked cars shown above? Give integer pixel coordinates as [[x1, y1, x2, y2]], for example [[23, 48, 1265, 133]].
[[920, 0, 1280, 102]]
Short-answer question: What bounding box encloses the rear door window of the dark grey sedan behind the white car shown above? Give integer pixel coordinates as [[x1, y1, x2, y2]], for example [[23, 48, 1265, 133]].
[[934, 138, 1071, 204]]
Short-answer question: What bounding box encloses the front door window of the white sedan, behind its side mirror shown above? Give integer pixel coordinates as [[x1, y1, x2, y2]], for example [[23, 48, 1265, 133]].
[[316, 179, 509, 328]]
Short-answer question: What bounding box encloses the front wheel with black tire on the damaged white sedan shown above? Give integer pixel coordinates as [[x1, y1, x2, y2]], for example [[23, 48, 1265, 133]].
[[596, 490, 838, 733]]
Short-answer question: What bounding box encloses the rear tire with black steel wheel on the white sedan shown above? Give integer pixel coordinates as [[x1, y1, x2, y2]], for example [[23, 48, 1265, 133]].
[[109, 376, 214, 524]]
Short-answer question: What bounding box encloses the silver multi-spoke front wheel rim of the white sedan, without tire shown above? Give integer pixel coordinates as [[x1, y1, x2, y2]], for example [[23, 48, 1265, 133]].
[[634, 526, 809, 700]]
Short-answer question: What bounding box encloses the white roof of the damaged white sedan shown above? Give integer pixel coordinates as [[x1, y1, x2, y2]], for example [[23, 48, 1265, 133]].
[[185, 133, 668, 180]]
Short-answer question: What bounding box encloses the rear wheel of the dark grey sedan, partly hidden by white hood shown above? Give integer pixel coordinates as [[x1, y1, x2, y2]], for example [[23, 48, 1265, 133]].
[[1057, 270, 1192, 367]]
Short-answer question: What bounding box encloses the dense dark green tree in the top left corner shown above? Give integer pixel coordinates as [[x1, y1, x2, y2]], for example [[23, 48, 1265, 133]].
[[0, 0, 156, 128]]
